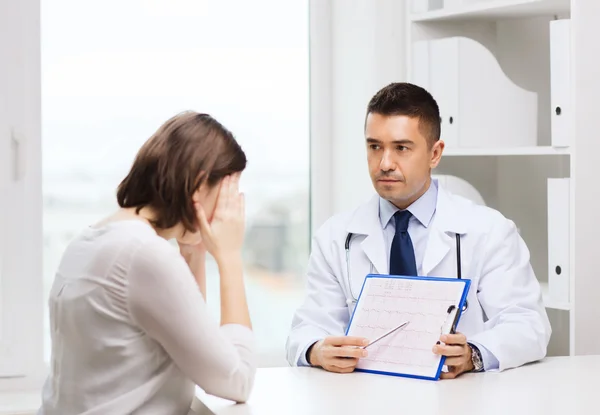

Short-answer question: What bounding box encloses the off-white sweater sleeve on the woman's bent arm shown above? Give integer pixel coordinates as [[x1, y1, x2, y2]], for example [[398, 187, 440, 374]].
[[127, 241, 256, 402]]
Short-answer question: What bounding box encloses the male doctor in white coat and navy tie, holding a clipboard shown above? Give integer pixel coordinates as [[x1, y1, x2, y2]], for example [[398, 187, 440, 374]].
[[286, 83, 551, 378]]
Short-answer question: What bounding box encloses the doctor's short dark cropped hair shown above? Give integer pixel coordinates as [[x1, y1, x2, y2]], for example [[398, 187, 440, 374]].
[[367, 82, 441, 147]]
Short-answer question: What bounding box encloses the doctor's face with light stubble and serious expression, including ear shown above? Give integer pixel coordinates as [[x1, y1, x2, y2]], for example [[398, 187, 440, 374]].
[[365, 113, 444, 209]]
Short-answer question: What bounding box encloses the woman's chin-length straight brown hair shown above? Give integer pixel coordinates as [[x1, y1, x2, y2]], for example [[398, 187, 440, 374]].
[[117, 111, 246, 232]]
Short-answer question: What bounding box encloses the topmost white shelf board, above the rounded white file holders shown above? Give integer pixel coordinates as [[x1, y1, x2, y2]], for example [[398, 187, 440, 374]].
[[410, 0, 570, 22]]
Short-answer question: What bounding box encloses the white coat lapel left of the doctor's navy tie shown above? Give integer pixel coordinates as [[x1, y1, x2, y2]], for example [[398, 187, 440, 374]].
[[347, 195, 389, 274]]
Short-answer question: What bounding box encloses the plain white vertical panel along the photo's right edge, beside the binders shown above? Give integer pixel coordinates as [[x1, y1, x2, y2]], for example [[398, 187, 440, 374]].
[[571, 0, 600, 355]]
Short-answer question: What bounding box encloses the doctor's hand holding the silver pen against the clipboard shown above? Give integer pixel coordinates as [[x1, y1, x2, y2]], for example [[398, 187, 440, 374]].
[[308, 336, 369, 373]]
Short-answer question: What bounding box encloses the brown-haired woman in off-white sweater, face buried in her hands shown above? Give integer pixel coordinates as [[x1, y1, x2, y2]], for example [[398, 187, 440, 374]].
[[39, 113, 255, 415]]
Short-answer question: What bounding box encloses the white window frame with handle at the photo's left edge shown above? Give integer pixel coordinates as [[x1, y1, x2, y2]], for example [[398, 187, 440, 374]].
[[0, 0, 45, 391]]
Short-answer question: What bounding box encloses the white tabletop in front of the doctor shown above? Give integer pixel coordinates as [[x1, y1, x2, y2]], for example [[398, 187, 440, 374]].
[[195, 356, 600, 415]]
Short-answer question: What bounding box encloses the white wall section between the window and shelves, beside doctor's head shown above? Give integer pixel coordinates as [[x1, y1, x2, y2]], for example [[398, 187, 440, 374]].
[[311, 0, 406, 229]]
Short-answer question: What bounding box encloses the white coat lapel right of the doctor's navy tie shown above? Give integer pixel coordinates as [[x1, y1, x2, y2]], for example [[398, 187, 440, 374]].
[[422, 183, 467, 277]]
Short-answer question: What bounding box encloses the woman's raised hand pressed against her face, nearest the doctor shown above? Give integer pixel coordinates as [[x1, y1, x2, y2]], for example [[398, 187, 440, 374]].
[[197, 174, 245, 263]]
